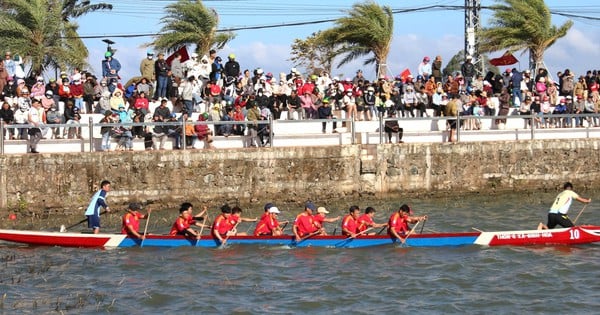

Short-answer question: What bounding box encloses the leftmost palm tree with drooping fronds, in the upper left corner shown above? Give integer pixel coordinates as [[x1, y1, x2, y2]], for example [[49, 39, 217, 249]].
[[0, 0, 112, 73]]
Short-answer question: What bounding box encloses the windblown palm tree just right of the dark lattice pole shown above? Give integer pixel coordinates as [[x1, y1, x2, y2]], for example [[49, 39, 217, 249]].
[[480, 0, 573, 69]]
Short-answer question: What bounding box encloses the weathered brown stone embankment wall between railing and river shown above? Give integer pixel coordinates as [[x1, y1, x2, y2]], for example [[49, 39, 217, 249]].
[[0, 139, 600, 214]]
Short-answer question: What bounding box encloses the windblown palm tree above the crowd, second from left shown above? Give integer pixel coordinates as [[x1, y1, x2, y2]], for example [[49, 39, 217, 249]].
[[149, 0, 235, 54]]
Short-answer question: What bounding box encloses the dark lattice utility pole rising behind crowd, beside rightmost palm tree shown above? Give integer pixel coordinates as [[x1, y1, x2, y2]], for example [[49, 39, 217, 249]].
[[464, 0, 484, 74]]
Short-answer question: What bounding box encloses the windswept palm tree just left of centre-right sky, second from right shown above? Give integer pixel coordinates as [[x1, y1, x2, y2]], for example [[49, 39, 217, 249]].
[[322, 1, 394, 76]]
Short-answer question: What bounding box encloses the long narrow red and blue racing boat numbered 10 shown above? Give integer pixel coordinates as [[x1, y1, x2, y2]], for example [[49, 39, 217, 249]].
[[0, 225, 600, 248]]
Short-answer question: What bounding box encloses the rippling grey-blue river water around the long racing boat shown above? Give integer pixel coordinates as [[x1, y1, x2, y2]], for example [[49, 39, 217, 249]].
[[0, 192, 600, 314]]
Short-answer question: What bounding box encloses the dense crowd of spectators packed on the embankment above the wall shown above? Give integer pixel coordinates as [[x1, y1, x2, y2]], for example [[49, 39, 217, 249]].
[[0, 50, 600, 150]]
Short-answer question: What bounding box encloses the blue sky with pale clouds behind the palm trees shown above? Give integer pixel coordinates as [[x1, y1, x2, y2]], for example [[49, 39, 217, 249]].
[[77, 0, 600, 78]]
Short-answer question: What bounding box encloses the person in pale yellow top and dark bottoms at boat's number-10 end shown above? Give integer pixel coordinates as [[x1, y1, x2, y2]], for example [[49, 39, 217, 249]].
[[538, 182, 592, 230]]
